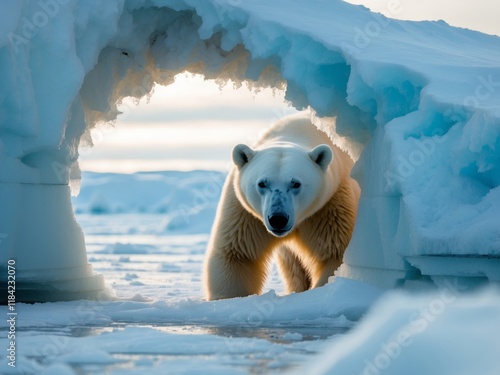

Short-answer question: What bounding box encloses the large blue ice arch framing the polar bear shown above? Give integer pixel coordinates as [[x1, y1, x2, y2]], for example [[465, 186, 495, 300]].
[[0, 0, 500, 300]]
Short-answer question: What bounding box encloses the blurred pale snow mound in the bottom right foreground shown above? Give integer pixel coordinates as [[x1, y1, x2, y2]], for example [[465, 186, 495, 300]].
[[304, 290, 500, 375]]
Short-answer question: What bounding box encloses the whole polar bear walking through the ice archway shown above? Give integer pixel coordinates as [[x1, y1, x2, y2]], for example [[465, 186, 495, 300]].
[[204, 113, 360, 300]]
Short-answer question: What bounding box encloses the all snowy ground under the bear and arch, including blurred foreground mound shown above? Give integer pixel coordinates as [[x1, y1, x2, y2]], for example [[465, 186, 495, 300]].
[[0, 171, 500, 375]]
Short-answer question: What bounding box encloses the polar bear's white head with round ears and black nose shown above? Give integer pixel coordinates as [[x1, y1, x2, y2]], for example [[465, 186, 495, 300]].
[[233, 142, 336, 237]]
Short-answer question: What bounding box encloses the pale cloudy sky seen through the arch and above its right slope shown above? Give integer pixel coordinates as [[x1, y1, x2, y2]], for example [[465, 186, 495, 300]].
[[80, 0, 500, 173]]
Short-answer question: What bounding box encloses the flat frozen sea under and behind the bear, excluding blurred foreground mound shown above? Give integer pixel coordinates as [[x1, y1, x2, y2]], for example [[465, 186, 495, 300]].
[[0, 171, 377, 374]]
